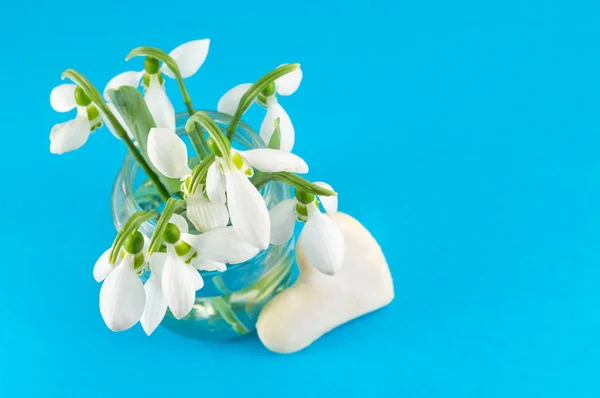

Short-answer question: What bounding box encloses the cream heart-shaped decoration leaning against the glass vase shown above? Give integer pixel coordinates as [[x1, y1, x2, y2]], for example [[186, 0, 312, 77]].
[[256, 212, 394, 353]]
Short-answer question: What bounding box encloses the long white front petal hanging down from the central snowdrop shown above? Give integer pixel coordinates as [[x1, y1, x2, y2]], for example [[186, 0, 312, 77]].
[[225, 168, 271, 249]]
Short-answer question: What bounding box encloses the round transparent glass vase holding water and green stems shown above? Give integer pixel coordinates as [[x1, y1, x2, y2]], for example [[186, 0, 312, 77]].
[[111, 112, 294, 340]]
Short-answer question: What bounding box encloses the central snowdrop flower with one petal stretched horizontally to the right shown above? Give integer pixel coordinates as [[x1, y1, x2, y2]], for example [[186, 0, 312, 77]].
[[206, 148, 308, 249]]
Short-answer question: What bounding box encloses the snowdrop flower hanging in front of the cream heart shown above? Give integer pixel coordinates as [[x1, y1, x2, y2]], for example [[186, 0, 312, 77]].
[[269, 182, 344, 275]]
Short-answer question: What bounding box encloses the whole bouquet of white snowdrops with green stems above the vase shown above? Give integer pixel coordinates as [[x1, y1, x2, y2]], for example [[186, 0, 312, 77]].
[[50, 39, 344, 335]]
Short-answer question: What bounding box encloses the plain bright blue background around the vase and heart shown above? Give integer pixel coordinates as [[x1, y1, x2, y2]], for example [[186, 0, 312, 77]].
[[0, 0, 600, 397]]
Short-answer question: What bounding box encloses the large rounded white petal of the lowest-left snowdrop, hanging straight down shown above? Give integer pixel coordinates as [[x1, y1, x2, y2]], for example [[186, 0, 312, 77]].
[[100, 256, 146, 332]]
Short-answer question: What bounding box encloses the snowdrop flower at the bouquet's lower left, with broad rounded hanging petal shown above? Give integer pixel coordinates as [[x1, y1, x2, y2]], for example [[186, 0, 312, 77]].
[[94, 232, 146, 332]]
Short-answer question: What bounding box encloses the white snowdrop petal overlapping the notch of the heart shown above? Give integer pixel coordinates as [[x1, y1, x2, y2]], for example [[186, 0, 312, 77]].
[[300, 205, 344, 275]]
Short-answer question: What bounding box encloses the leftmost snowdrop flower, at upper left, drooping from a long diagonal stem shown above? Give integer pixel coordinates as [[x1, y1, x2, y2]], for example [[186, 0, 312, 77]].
[[50, 84, 102, 155]]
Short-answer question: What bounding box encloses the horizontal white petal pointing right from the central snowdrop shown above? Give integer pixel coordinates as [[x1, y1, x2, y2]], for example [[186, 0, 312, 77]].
[[237, 148, 308, 174]]
